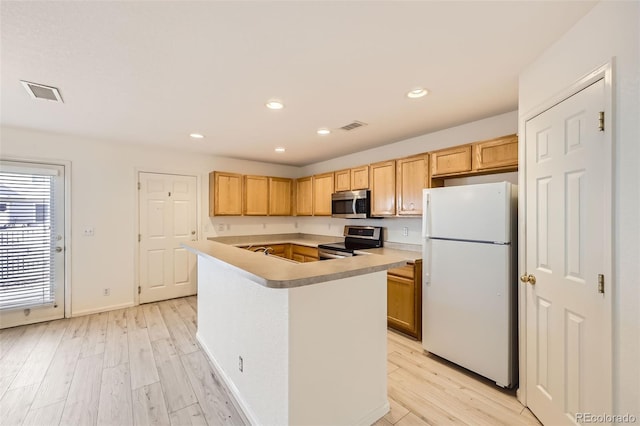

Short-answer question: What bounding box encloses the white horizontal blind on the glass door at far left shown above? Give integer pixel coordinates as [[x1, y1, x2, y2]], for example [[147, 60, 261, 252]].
[[0, 169, 56, 310]]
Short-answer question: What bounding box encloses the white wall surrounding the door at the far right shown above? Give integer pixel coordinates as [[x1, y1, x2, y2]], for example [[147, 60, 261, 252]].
[[519, 1, 640, 416]]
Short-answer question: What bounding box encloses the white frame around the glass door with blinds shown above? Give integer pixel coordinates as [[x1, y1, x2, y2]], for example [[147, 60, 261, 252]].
[[2, 157, 72, 318]]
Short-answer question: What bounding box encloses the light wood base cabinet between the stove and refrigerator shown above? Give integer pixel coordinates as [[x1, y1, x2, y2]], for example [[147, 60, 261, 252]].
[[387, 259, 422, 340]]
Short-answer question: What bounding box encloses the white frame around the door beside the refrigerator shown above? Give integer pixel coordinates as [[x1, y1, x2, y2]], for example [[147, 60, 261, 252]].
[[516, 58, 616, 406]]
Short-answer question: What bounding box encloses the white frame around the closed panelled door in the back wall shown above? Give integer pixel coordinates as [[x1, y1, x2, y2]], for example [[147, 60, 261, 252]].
[[136, 167, 203, 306]]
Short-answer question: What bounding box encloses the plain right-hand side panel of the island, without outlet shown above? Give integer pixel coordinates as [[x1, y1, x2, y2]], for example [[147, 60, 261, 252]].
[[289, 271, 389, 426]]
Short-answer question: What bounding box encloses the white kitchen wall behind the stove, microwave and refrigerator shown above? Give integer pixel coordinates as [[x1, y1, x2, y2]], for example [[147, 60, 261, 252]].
[[295, 111, 518, 244]]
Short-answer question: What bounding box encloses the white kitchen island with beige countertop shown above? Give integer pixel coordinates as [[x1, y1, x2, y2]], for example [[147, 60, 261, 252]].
[[185, 241, 405, 425]]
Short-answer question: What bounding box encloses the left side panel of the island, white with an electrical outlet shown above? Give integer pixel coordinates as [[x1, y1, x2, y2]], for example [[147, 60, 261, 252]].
[[197, 255, 290, 425]]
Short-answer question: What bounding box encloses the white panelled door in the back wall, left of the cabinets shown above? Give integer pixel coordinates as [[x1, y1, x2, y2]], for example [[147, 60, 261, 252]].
[[138, 173, 197, 303]]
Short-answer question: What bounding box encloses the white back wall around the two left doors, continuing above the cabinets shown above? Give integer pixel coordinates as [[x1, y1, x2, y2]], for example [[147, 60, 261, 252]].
[[0, 127, 298, 315]]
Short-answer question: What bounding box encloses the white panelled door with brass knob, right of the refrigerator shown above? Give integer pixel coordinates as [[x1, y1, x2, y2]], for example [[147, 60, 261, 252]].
[[521, 79, 612, 425]]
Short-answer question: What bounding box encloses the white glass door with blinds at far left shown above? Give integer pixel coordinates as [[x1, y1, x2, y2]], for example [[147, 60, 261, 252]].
[[0, 161, 65, 328]]
